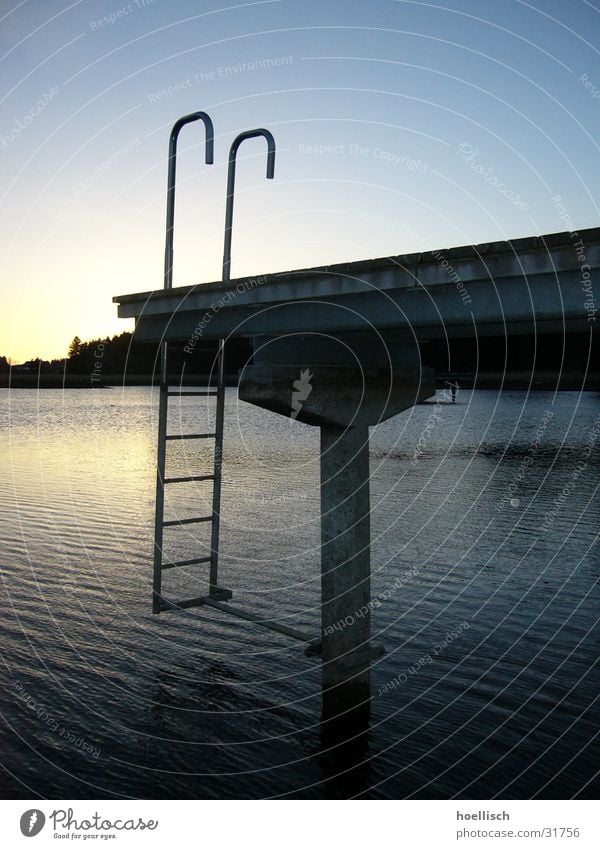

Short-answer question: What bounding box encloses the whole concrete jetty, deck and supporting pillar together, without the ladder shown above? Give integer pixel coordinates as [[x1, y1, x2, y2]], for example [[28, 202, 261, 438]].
[[115, 228, 600, 717]]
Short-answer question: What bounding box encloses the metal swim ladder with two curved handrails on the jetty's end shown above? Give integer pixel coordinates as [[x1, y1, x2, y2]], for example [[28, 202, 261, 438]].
[[152, 117, 278, 616]]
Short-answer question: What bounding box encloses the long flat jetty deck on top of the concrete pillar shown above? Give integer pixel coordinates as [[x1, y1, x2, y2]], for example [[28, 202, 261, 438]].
[[114, 227, 600, 341]]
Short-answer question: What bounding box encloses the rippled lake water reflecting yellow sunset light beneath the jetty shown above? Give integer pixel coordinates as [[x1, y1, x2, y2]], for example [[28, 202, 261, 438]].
[[0, 388, 600, 799]]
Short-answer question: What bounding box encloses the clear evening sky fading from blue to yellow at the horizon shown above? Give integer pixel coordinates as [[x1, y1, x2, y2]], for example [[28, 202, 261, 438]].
[[0, 0, 600, 362]]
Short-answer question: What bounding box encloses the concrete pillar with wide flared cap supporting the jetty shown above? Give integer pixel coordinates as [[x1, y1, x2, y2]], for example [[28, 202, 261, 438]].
[[238, 348, 435, 733]]
